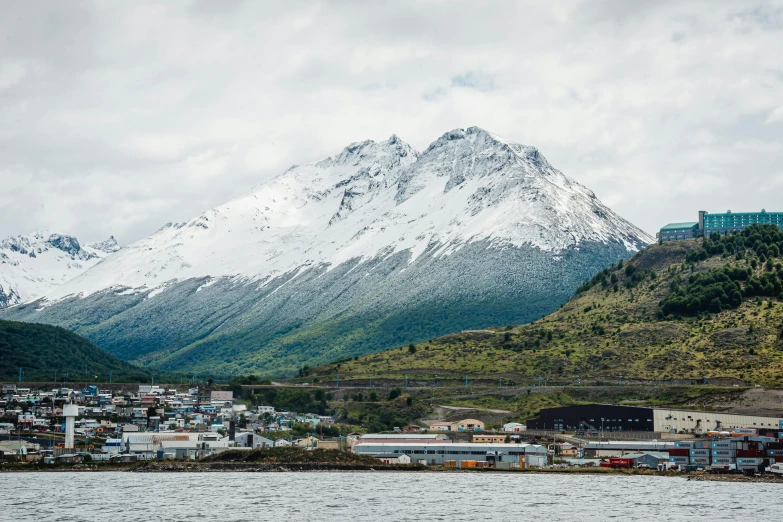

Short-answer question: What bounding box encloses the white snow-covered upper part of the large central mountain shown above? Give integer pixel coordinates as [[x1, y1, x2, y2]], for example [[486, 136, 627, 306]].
[[47, 127, 652, 300]]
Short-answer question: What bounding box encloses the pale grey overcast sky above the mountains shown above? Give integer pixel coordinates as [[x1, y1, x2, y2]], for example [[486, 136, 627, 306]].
[[0, 0, 783, 244]]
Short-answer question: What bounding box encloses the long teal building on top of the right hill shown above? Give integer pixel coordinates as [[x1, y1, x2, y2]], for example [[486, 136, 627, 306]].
[[656, 209, 783, 243]]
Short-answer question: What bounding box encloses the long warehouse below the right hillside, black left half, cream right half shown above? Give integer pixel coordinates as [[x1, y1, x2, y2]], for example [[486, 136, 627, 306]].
[[527, 404, 783, 434]]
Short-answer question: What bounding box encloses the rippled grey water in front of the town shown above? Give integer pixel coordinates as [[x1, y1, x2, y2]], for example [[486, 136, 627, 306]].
[[0, 472, 783, 522]]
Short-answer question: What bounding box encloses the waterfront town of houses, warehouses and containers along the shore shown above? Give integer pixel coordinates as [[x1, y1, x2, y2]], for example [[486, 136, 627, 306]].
[[0, 384, 783, 474]]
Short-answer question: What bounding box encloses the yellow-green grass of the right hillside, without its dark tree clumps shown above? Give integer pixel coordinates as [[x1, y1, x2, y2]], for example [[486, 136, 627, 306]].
[[312, 239, 783, 384]]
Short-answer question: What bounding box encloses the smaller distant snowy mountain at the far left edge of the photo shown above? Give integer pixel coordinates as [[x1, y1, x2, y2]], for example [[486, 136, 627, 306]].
[[0, 231, 120, 308]]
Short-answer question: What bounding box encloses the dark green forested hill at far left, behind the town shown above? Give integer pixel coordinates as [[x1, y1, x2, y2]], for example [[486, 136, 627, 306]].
[[0, 321, 148, 382]]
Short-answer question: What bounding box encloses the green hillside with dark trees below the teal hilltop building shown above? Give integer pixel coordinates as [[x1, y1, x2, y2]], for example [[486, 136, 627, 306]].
[[310, 225, 783, 385]]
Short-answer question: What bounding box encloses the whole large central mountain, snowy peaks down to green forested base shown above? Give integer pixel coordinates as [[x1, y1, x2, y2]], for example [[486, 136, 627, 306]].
[[5, 127, 652, 373]]
